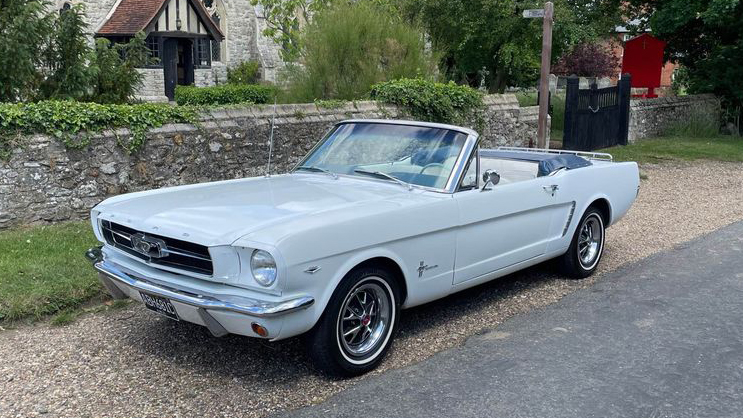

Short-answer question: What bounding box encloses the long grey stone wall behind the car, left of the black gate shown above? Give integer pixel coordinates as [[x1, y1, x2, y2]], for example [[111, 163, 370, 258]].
[[0, 95, 537, 229]]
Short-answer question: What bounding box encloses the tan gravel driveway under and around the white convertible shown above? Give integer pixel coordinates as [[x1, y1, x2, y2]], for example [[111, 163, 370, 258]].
[[0, 162, 743, 417]]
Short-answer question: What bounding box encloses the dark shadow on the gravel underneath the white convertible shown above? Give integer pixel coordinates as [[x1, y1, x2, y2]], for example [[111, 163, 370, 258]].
[[122, 264, 576, 388]]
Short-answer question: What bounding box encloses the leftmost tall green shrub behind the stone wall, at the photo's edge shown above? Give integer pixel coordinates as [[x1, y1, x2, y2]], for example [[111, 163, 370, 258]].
[[0, 0, 55, 102]]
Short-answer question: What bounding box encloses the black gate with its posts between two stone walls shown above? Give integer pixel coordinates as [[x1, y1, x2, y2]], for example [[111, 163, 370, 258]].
[[562, 74, 630, 151]]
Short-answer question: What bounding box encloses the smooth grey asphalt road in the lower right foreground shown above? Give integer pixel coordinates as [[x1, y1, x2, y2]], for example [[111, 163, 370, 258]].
[[283, 222, 743, 418]]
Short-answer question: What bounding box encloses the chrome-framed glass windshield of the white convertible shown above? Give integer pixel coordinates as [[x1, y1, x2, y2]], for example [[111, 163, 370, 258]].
[[298, 123, 467, 189]]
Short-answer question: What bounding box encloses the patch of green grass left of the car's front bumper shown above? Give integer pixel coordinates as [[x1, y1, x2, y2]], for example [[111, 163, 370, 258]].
[[0, 222, 101, 323]]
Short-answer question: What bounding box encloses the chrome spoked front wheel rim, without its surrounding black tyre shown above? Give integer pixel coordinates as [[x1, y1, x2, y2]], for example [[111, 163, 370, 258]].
[[337, 277, 394, 360]]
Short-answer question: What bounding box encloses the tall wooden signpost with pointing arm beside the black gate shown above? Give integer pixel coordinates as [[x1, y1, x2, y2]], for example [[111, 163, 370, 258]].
[[523, 1, 554, 148]]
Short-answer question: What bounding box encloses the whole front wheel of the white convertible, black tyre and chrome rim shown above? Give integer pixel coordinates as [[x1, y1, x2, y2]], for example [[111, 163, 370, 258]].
[[307, 267, 400, 376]]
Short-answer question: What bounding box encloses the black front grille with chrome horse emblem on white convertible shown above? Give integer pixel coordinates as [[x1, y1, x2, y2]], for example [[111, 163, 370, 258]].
[[101, 221, 214, 276]]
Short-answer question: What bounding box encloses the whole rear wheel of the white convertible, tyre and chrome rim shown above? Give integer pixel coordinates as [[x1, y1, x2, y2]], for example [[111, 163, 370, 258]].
[[558, 207, 606, 279]]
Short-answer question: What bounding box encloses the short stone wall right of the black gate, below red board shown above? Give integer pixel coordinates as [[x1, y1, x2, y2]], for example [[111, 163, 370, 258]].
[[629, 94, 720, 142]]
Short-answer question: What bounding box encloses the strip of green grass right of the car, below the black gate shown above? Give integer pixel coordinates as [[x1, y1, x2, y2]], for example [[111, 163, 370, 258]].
[[600, 136, 743, 164]]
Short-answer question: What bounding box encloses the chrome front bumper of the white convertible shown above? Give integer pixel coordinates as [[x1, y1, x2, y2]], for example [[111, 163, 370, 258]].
[[94, 260, 315, 317]]
